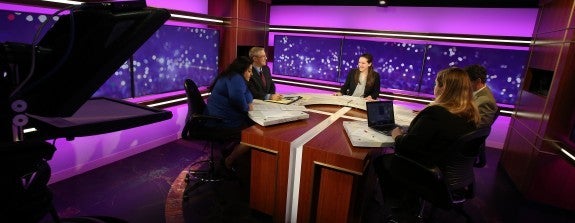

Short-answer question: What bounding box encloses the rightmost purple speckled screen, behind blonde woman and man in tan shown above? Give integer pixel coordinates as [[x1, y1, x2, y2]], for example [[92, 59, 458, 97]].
[[420, 45, 529, 104]]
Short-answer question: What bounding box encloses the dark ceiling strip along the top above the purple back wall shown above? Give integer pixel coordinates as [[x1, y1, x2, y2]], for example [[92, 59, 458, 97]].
[[272, 0, 538, 8]]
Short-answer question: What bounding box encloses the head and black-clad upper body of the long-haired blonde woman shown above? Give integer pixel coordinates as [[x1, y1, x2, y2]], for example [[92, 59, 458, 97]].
[[391, 67, 480, 161]]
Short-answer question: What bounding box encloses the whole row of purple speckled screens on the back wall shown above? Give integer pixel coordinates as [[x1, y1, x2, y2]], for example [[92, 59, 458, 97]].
[[273, 35, 529, 104]]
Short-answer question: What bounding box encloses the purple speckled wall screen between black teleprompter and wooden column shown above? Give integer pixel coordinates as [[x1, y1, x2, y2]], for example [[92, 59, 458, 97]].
[[134, 25, 219, 97]]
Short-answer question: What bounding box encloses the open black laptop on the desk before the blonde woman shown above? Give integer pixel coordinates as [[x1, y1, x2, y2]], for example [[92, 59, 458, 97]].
[[366, 101, 397, 135]]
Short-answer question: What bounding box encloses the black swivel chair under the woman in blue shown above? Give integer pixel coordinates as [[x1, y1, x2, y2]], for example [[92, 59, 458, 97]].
[[182, 79, 241, 189]]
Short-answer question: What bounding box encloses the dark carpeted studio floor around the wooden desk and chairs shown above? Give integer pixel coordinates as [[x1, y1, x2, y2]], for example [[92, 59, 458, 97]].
[[42, 140, 575, 223]]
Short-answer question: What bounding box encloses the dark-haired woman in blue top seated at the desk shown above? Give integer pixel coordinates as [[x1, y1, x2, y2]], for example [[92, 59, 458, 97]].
[[204, 56, 254, 170]]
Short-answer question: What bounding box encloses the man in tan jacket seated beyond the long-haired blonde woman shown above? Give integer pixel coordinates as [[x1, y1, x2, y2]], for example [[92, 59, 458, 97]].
[[465, 64, 498, 127]]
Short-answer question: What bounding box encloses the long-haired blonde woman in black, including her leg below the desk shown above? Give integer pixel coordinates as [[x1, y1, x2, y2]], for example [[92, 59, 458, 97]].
[[373, 67, 480, 222]]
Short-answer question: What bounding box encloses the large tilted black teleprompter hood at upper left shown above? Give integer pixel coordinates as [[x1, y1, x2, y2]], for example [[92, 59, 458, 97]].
[[11, 1, 170, 117]]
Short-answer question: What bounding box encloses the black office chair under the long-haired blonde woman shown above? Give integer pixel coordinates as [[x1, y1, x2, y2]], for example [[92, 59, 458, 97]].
[[390, 127, 491, 222]]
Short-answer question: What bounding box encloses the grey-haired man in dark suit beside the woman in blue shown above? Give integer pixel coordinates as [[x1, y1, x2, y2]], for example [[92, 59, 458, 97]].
[[248, 47, 282, 100]]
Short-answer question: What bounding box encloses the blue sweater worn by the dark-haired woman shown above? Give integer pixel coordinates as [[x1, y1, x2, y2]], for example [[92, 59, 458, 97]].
[[204, 74, 253, 128]]
